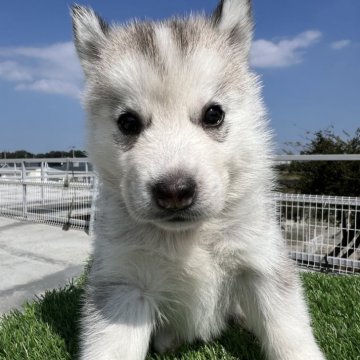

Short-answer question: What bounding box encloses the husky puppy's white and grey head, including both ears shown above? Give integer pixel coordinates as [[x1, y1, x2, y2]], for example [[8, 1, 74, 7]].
[[72, 0, 270, 230]]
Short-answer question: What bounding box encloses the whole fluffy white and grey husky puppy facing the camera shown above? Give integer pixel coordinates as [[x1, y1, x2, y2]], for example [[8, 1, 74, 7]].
[[72, 0, 324, 360]]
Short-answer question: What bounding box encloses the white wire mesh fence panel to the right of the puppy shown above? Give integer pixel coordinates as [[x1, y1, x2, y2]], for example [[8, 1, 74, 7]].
[[274, 193, 360, 273]]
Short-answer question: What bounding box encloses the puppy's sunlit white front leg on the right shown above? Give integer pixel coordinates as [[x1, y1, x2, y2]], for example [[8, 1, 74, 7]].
[[239, 264, 325, 360]]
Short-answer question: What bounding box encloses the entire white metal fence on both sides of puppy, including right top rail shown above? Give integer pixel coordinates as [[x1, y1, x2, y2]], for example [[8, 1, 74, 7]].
[[0, 155, 360, 274]]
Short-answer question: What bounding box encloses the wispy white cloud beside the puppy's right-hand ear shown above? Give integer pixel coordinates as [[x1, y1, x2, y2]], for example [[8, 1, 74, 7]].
[[250, 30, 322, 68]]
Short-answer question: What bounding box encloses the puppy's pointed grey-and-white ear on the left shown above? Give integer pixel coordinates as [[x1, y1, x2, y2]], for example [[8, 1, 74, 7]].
[[71, 5, 109, 74]]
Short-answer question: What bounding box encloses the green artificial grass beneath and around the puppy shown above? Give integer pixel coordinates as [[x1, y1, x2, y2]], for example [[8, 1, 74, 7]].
[[0, 273, 360, 360]]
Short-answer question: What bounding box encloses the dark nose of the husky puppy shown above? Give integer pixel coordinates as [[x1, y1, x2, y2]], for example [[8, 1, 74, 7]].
[[151, 175, 196, 210]]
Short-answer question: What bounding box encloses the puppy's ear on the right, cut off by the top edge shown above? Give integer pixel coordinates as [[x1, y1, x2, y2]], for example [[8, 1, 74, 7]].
[[212, 0, 253, 56]]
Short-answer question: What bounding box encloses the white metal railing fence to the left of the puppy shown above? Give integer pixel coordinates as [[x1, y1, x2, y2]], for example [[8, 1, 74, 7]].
[[0, 159, 96, 230]]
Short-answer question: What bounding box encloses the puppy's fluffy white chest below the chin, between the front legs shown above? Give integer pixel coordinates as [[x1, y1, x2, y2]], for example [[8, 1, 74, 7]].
[[102, 242, 230, 338]]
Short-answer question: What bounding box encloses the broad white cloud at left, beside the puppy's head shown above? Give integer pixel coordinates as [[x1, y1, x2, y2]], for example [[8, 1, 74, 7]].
[[0, 42, 83, 97]]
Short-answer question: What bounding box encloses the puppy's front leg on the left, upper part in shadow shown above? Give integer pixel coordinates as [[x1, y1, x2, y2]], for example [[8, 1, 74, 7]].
[[80, 283, 155, 360]]
